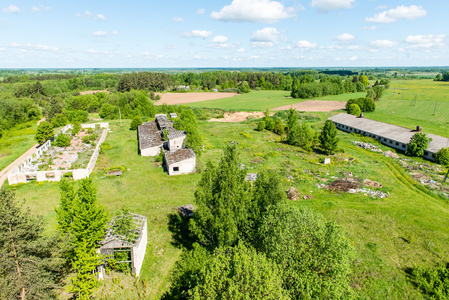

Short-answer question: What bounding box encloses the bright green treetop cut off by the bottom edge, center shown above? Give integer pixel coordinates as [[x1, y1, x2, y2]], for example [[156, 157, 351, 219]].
[[189, 242, 289, 300]]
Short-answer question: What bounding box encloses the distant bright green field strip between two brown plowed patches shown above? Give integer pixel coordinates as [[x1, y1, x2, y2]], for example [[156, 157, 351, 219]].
[[186, 91, 366, 111]]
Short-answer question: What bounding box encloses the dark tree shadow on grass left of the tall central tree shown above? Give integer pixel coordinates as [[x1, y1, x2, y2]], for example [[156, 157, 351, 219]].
[[168, 212, 196, 250]]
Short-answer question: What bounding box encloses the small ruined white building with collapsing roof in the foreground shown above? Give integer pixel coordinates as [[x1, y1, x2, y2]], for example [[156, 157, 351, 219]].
[[99, 213, 148, 278]]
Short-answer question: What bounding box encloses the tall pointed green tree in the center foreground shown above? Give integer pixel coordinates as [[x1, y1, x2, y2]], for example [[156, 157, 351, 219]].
[[190, 145, 251, 249]]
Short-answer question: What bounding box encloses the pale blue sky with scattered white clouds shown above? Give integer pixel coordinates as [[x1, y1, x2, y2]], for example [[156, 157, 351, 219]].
[[0, 0, 449, 68]]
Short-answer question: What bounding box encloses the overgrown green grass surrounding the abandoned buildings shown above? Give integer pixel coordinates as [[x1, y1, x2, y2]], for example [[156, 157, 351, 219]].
[[8, 113, 449, 299]]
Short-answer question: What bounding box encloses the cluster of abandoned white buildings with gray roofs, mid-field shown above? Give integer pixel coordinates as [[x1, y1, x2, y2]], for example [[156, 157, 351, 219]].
[[138, 114, 196, 175]]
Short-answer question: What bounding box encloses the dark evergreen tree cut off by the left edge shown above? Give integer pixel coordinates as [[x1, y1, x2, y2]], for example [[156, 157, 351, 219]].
[[0, 189, 65, 299]]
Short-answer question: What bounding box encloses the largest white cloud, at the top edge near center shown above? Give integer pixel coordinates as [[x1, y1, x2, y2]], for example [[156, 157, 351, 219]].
[[210, 0, 296, 24]]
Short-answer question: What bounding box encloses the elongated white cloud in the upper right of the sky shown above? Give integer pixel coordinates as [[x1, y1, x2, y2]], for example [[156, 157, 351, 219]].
[[365, 5, 427, 23]]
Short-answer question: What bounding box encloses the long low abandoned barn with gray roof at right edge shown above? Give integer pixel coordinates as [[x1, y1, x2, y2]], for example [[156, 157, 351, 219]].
[[329, 113, 449, 161]]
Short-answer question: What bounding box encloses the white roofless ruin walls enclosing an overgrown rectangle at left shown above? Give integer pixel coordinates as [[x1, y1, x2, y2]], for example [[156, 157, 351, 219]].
[[8, 123, 109, 185]]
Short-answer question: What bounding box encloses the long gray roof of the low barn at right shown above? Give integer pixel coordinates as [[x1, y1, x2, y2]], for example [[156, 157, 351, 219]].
[[329, 113, 449, 153]]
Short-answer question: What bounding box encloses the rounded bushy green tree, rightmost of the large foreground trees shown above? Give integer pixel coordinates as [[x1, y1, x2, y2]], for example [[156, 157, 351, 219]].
[[257, 205, 354, 299]]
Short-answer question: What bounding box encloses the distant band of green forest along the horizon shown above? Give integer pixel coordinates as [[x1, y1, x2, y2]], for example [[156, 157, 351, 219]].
[[0, 67, 449, 135]]
